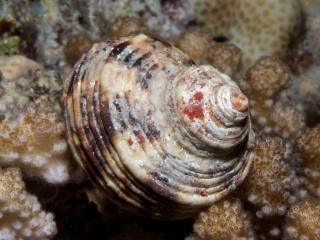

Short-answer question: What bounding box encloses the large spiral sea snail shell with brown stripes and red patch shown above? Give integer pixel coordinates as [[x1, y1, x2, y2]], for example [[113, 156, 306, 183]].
[[63, 35, 254, 220]]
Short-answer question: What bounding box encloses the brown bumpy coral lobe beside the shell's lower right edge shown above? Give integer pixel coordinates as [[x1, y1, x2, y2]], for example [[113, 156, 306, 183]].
[[238, 136, 299, 218]]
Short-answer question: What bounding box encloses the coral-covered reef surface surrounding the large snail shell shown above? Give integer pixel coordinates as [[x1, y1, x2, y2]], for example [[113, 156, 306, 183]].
[[0, 0, 320, 240]]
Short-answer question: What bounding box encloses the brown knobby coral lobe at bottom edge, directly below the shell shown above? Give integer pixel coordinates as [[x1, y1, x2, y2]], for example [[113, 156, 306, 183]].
[[186, 199, 255, 240]]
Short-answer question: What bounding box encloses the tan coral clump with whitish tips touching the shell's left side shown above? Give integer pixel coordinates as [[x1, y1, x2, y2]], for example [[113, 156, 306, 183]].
[[0, 99, 80, 183]]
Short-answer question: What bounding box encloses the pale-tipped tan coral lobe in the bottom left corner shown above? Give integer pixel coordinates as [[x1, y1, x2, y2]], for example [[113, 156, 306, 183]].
[[0, 168, 57, 239]]
